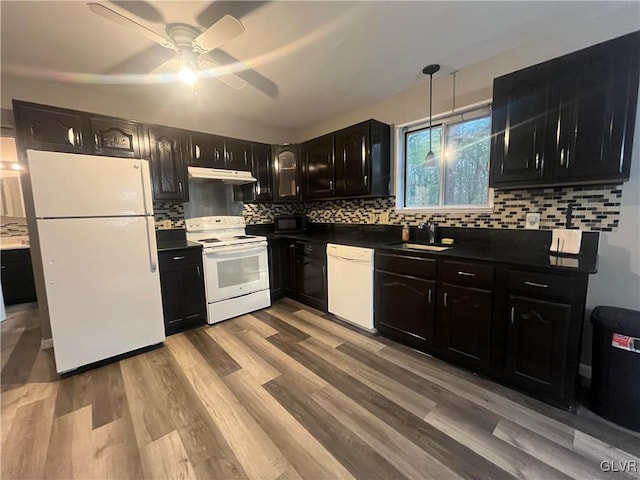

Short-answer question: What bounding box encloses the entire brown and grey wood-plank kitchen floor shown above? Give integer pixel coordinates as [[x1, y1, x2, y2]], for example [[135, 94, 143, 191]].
[[0, 300, 640, 480]]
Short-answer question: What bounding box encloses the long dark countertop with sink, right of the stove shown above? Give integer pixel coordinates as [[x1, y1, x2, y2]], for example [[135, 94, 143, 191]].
[[247, 224, 599, 274]]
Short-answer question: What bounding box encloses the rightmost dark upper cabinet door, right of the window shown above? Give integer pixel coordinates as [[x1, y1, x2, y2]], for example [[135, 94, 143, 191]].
[[553, 34, 640, 182]]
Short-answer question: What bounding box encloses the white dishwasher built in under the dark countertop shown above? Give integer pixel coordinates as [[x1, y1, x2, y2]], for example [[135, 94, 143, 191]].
[[327, 243, 375, 331]]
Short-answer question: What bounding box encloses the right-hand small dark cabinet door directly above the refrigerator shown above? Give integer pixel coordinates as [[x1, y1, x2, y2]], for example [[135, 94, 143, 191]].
[[89, 117, 143, 158]]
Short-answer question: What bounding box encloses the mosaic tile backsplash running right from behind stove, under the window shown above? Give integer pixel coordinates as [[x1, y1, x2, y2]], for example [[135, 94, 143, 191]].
[[243, 185, 622, 232]]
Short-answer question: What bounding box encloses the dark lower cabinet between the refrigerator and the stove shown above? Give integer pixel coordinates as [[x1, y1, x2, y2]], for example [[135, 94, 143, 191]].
[[159, 248, 207, 335]]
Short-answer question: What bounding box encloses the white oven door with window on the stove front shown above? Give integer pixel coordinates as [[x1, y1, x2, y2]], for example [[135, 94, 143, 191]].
[[204, 242, 269, 303]]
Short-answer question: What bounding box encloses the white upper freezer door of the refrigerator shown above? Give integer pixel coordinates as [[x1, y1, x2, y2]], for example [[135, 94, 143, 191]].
[[27, 150, 153, 218]]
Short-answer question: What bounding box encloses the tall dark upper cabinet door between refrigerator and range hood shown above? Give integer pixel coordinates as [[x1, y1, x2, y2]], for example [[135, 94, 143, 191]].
[[149, 126, 189, 202]]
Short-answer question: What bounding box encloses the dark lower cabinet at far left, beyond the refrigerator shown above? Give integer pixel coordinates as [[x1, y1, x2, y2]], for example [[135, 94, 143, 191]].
[[2, 248, 36, 305]]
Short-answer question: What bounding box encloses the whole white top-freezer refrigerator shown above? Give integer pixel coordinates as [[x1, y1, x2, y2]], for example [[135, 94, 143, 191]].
[[27, 150, 165, 373]]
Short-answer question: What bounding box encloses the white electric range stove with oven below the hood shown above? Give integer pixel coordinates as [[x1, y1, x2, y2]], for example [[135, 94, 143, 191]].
[[186, 216, 271, 324]]
